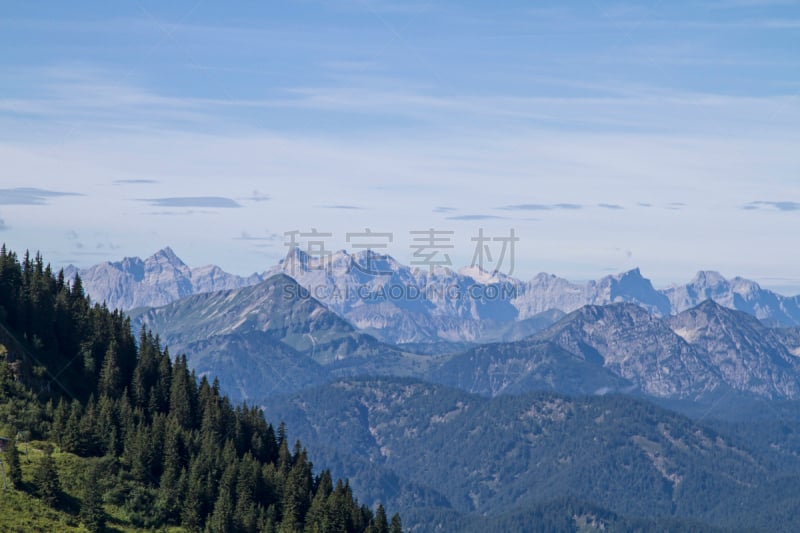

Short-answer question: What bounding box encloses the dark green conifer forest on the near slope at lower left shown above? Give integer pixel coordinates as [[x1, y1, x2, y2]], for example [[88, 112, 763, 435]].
[[0, 246, 402, 533]]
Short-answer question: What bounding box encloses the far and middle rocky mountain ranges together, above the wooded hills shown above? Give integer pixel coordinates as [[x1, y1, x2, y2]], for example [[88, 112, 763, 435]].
[[59, 249, 800, 405]]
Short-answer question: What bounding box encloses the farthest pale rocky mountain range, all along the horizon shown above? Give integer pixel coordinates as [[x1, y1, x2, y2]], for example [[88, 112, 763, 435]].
[[66, 248, 800, 342]]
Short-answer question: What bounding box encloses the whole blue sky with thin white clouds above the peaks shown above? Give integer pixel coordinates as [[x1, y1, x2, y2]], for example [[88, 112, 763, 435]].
[[0, 0, 800, 294]]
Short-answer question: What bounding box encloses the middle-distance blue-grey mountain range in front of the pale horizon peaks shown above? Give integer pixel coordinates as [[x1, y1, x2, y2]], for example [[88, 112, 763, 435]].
[[122, 273, 800, 405]]
